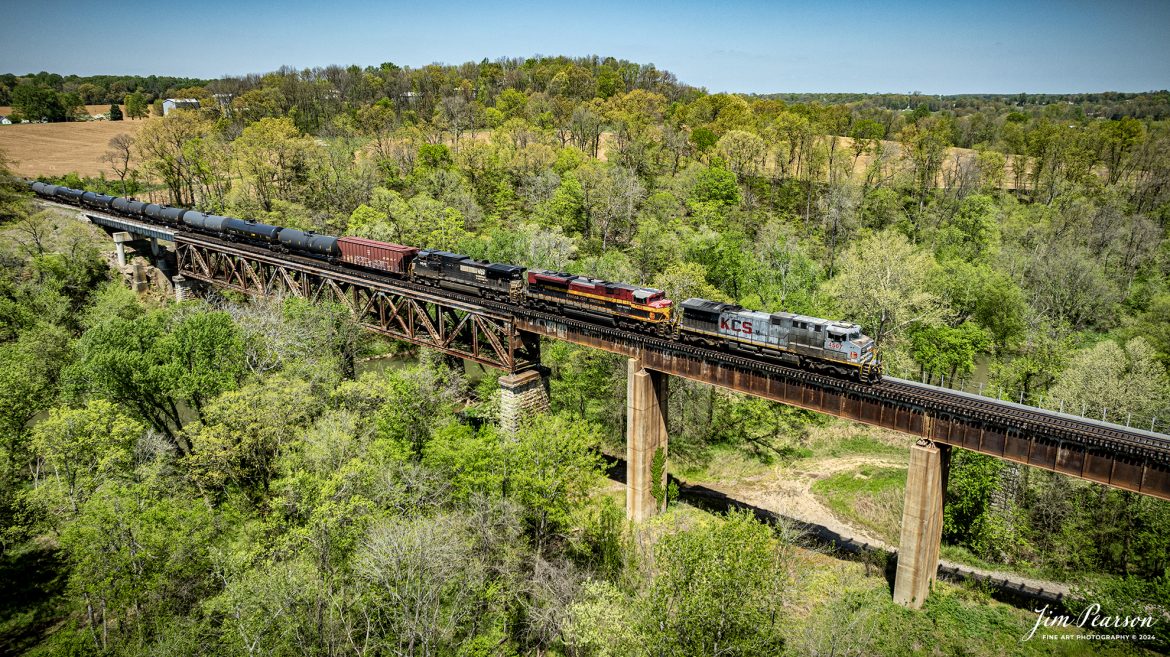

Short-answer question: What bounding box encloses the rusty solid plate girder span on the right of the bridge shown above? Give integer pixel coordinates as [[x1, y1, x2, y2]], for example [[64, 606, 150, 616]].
[[517, 310, 1170, 499]]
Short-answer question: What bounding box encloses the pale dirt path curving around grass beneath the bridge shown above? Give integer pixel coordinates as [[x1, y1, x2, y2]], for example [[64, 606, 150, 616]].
[[683, 455, 1071, 596]]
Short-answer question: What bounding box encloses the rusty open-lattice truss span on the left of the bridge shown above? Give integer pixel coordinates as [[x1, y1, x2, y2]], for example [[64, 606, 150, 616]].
[[176, 235, 541, 372]]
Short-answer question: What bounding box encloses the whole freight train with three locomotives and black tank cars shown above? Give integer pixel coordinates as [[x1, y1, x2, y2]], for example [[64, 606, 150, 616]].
[[28, 181, 882, 383]]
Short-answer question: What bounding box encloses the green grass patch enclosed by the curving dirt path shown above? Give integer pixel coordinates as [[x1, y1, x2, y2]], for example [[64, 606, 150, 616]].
[[812, 465, 906, 545]]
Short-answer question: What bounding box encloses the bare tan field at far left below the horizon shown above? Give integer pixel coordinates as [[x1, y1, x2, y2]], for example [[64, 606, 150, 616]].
[[0, 115, 150, 177]]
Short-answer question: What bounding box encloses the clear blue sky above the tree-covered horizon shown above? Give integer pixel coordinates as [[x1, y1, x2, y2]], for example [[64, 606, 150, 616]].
[[0, 0, 1170, 94]]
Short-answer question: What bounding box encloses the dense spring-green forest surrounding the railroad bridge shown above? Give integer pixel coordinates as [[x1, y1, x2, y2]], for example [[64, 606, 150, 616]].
[[0, 57, 1170, 655]]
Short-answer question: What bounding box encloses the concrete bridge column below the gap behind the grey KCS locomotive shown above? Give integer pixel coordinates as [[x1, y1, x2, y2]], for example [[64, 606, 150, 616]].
[[626, 358, 668, 523]]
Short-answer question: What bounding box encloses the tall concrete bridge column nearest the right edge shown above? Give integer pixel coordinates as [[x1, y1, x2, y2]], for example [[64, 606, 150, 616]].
[[894, 438, 950, 609]]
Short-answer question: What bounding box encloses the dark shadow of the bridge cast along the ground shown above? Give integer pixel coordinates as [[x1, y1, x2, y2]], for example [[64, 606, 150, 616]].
[[605, 455, 1065, 611]]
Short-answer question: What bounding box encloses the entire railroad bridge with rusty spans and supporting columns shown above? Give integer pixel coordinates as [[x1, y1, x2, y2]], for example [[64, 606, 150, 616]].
[[66, 206, 1170, 607]]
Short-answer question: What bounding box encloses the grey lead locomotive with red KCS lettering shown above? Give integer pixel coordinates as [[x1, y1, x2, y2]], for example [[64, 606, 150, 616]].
[[679, 298, 881, 382]]
